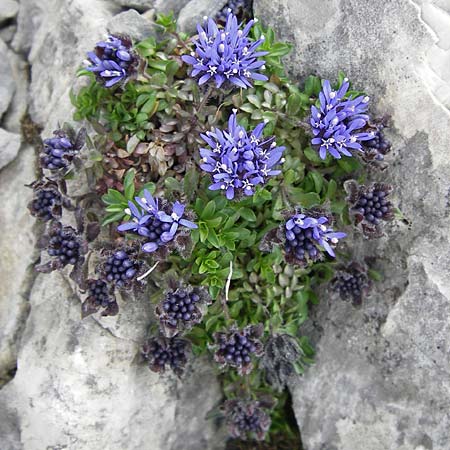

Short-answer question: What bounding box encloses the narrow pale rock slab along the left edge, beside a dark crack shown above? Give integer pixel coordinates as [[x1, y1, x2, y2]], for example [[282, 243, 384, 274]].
[[0, 146, 36, 384]]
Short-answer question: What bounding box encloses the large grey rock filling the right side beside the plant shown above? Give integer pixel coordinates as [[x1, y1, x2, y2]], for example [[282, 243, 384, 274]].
[[254, 0, 450, 450]]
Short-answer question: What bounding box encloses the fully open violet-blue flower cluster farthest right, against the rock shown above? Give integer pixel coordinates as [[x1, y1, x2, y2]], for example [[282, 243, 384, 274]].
[[310, 79, 375, 159]]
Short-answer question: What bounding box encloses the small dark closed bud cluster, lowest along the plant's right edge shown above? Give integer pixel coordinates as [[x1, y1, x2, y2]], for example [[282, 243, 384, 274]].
[[333, 262, 371, 305]]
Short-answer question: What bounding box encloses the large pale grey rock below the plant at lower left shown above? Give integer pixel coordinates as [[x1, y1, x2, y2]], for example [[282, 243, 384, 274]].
[[0, 273, 225, 450]]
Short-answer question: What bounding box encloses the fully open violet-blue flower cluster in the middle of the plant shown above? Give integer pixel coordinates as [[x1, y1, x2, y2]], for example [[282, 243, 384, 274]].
[[200, 111, 285, 200]]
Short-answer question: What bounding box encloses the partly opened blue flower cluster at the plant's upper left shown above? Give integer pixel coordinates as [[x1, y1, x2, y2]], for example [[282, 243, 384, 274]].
[[86, 35, 139, 87]]
